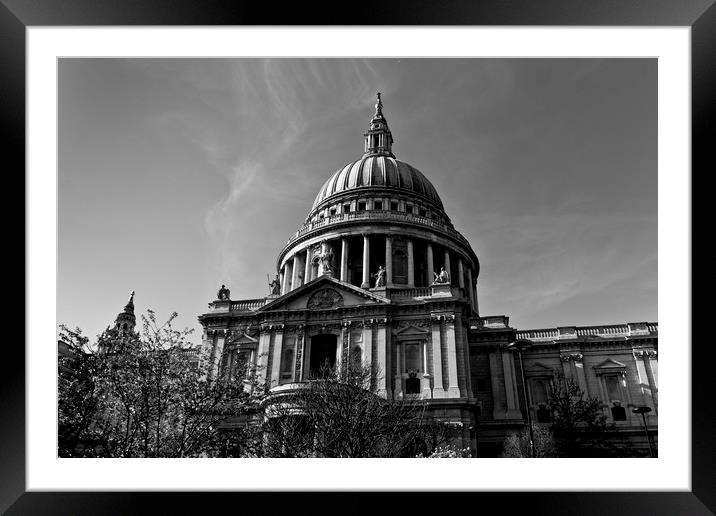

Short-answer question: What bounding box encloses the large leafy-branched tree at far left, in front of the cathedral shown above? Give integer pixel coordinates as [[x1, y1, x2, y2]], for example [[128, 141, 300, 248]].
[[58, 310, 263, 457]]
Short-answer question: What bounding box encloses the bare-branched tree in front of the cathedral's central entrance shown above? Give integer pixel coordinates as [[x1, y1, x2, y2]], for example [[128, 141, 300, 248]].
[[261, 360, 455, 457]]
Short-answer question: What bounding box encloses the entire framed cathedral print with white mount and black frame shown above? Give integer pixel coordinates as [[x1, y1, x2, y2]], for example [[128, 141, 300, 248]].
[[8, 1, 716, 514]]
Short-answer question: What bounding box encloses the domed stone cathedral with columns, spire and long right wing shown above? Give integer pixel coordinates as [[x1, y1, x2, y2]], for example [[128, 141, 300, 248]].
[[199, 94, 658, 456]]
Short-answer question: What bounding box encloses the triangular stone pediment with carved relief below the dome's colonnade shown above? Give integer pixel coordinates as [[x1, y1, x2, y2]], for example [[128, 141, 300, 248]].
[[258, 276, 390, 312]]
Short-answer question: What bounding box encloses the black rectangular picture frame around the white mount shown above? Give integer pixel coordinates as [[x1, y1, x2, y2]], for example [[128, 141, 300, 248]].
[[0, 0, 716, 515]]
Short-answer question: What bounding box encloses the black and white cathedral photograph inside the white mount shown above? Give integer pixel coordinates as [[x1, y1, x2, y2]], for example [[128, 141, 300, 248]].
[[57, 57, 660, 459]]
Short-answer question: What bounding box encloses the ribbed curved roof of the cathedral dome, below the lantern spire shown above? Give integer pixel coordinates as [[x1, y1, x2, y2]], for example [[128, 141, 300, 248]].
[[313, 153, 443, 210]]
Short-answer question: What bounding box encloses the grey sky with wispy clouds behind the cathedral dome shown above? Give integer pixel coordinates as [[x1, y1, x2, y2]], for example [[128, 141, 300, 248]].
[[57, 58, 657, 343]]
